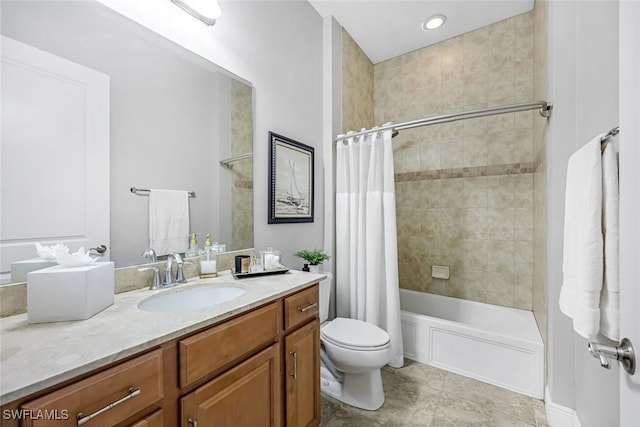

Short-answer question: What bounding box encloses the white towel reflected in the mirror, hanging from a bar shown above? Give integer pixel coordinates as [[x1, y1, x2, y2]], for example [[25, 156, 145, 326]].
[[149, 189, 189, 255]]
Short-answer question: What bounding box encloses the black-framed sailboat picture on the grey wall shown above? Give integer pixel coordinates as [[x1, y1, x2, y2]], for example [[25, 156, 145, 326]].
[[269, 132, 314, 224]]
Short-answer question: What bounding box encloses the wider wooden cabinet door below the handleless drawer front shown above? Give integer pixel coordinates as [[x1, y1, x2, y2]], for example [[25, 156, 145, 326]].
[[180, 344, 282, 427]]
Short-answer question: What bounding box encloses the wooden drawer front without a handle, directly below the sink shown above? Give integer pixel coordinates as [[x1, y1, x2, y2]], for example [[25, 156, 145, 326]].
[[178, 302, 280, 387]]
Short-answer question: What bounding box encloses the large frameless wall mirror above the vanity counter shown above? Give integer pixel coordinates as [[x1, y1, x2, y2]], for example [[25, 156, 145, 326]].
[[0, 1, 253, 283]]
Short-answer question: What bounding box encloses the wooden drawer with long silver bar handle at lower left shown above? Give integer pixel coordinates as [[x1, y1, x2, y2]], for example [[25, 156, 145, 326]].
[[22, 350, 163, 427]]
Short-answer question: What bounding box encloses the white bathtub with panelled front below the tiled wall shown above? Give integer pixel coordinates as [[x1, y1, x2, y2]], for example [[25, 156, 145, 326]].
[[400, 289, 544, 399]]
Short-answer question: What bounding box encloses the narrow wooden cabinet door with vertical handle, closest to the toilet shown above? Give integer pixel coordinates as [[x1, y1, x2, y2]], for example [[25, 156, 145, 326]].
[[285, 319, 320, 427]]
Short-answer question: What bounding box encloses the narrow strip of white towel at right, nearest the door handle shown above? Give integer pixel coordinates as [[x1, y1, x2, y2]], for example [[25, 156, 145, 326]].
[[600, 144, 620, 341]]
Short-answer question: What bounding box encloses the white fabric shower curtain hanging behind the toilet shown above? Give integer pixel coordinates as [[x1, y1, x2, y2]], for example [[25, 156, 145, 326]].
[[335, 129, 404, 368]]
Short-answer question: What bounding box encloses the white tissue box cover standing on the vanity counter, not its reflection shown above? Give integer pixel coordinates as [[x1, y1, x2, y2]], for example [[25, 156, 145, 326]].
[[27, 262, 115, 323]]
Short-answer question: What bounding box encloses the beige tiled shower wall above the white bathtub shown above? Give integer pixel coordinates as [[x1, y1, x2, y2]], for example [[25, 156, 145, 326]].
[[343, 13, 541, 310]]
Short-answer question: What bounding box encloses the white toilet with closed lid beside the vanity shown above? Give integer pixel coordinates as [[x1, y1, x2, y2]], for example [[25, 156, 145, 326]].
[[320, 275, 391, 411]]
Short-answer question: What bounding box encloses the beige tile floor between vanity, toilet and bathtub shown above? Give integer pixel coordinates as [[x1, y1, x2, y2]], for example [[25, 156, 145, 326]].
[[320, 359, 548, 427]]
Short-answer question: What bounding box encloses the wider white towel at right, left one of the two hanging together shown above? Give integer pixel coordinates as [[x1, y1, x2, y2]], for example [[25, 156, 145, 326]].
[[560, 135, 603, 339]]
